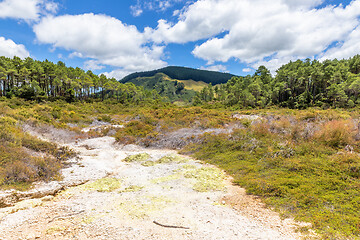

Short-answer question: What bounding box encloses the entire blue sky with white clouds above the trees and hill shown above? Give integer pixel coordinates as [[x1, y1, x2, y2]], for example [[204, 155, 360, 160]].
[[0, 0, 360, 79]]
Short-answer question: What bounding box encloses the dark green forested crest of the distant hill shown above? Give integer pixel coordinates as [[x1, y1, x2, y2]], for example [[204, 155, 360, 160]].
[[121, 66, 235, 85]]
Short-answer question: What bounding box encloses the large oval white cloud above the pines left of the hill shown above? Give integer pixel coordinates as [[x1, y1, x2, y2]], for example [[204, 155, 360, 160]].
[[33, 13, 166, 79]]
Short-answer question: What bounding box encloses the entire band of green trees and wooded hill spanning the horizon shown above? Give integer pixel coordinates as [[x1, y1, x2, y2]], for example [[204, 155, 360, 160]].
[[0, 55, 360, 109]]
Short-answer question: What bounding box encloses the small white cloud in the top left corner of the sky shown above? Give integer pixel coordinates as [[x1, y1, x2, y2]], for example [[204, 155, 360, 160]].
[[0, 0, 58, 20]]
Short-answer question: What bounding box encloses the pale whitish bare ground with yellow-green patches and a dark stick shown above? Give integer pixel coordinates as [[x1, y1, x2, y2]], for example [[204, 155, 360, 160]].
[[0, 137, 312, 240]]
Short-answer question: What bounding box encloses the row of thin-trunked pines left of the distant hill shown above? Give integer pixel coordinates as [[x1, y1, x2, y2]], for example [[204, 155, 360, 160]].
[[0, 56, 159, 103]]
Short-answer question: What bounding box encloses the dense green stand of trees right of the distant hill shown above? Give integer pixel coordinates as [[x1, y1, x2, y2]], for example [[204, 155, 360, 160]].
[[194, 55, 360, 109]]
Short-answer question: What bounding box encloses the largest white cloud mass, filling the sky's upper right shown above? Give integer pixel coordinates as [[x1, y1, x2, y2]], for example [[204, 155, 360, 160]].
[[145, 0, 360, 71]]
